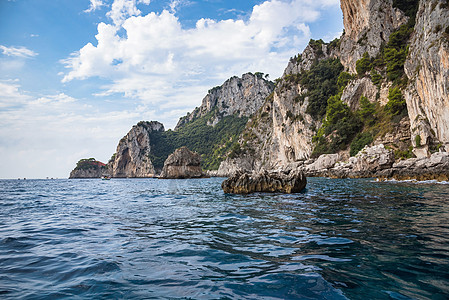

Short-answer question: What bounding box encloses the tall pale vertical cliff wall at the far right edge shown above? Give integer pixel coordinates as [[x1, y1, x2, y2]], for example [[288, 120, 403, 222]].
[[405, 1, 449, 157]]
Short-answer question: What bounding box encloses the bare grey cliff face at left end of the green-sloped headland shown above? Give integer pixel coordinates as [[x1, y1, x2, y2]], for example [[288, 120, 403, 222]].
[[109, 122, 164, 178]]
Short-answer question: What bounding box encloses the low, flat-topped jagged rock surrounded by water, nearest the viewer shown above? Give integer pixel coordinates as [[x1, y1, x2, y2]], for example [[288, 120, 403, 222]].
[[221, 171, 307, 194]]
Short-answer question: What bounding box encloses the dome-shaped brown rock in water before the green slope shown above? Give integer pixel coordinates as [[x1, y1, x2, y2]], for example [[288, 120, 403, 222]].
[[159, 147, 205, 179]]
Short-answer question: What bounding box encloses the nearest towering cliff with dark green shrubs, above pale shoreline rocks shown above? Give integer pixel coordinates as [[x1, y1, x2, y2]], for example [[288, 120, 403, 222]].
[[213, 0, 449, 176]]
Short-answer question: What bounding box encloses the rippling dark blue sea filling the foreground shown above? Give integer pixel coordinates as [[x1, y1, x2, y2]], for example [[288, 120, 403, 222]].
[[0, 178, 449, 300]]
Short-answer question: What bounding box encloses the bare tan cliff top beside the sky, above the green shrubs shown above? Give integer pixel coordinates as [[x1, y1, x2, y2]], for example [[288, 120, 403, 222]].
[[340, 0, 408, 73]]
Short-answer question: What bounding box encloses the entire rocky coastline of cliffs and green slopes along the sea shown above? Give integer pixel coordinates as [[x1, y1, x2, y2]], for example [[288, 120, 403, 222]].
[[70, 0, 449, 180]]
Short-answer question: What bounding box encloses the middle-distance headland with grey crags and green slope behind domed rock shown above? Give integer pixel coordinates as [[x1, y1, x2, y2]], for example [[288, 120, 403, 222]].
[[103, 73, 274, 177]]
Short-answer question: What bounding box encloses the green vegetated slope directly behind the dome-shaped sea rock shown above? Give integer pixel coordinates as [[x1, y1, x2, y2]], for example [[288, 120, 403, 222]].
[[150, 110, 248, 170]]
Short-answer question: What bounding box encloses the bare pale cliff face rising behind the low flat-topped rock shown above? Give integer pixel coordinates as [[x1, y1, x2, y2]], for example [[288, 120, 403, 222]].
[[214, 44, 336, 176]]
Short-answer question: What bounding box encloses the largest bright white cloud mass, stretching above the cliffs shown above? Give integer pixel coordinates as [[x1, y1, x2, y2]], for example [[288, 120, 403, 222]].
[[62, 0, 339, 123]]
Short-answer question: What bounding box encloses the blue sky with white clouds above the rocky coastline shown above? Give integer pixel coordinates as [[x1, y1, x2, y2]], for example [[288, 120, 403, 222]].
[[0, 0, 343, 179]]
